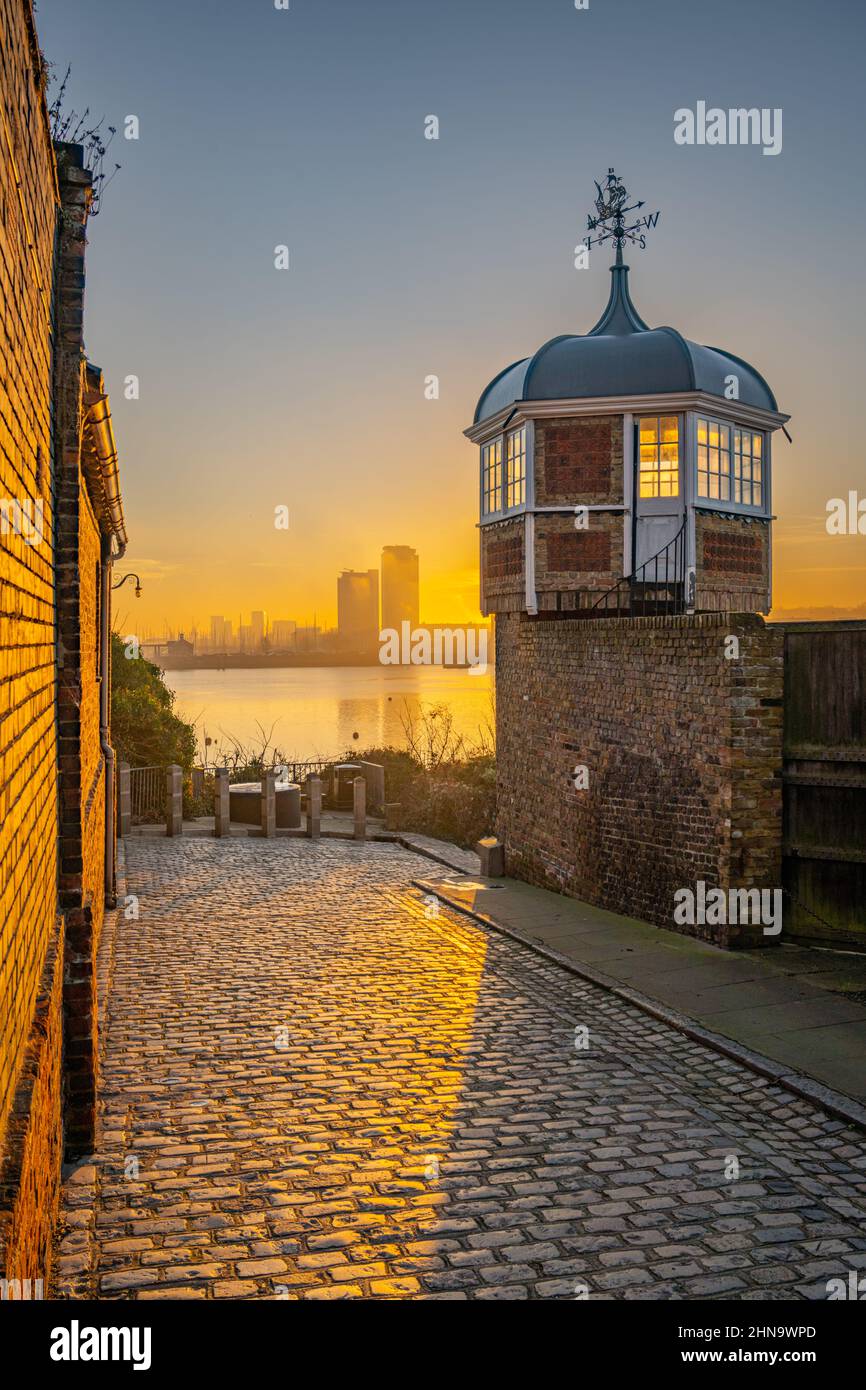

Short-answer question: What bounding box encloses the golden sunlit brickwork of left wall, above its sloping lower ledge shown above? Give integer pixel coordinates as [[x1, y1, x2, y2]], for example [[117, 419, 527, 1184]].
[[0, 0, 57, 1143]]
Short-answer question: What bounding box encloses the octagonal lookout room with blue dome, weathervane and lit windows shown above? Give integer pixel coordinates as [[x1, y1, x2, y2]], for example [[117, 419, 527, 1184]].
[[466, 171, 788, 617]]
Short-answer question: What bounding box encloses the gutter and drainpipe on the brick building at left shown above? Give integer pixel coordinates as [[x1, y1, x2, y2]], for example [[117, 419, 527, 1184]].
[[83, 363, 129, 908]]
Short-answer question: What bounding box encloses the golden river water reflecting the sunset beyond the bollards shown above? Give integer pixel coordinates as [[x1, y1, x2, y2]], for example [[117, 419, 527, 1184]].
[[165, 666, 493, 760]]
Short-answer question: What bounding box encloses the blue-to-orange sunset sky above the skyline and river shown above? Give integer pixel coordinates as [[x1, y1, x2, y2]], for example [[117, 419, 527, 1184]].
[[36, 0, 866, 631]]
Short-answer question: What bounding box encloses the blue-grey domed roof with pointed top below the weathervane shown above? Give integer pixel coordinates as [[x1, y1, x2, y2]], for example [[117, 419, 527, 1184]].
[[474, 265, 778, 424]]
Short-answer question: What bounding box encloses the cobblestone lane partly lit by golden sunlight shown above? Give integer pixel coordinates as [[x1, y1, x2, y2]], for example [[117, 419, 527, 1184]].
[[54, 838, 866, 1300]]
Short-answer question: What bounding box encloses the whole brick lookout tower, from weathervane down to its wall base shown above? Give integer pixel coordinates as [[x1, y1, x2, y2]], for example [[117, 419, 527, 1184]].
[[466, 171, 788, 945]]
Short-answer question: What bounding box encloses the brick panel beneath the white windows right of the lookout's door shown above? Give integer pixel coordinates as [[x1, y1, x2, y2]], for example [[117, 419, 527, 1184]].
[[695, 512, 770, 613]]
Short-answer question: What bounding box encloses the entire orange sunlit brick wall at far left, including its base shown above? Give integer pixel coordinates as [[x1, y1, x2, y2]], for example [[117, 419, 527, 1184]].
[[0, 0, 60, 1277]]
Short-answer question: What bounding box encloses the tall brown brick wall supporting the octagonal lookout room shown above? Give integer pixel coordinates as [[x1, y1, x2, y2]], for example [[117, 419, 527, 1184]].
[[496, 614, 783, 945]]
